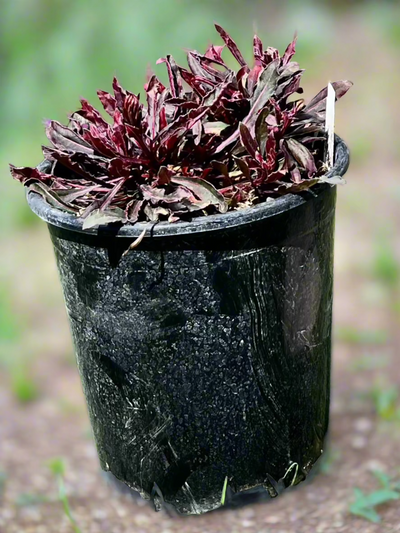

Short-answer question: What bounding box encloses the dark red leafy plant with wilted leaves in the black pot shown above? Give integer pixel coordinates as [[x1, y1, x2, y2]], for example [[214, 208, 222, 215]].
[[10, 25, 352, 228]]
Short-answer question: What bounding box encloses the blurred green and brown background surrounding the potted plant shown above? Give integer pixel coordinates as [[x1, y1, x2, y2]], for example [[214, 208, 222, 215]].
[[0, 0, 400, 533]]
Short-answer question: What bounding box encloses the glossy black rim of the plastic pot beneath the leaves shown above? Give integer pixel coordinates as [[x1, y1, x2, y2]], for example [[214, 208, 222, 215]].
[[26, 135, 350, 238]]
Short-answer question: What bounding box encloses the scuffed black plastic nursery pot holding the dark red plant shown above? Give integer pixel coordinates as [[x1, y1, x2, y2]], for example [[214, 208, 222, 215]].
[[28, 138, 349, 514]]
